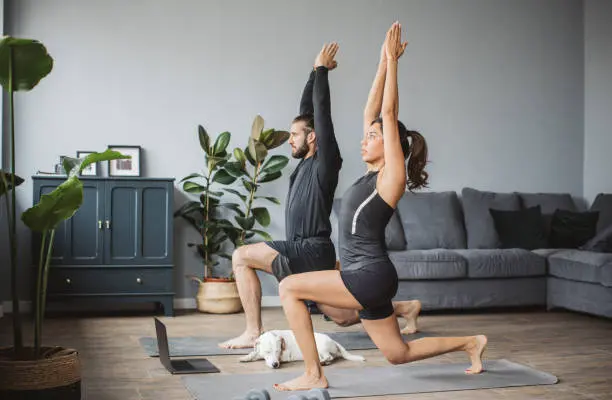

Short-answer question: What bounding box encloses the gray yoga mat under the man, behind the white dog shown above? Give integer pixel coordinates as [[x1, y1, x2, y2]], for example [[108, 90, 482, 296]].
[[139, 331, 434, 357]]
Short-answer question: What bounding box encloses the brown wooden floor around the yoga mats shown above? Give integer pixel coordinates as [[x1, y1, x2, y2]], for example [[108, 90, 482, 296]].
[[0, 309, 612, 400]]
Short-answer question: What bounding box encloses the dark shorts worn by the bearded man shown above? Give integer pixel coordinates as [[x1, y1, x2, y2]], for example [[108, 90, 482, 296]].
[[265, 237, 336, 282]]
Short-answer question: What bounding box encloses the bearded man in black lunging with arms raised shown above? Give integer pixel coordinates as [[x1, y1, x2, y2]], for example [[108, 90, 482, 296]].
[[219, 43, 420, 348]]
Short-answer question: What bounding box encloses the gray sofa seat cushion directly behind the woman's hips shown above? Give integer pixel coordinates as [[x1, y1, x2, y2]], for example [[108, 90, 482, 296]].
[[389, 249, 466, 280]]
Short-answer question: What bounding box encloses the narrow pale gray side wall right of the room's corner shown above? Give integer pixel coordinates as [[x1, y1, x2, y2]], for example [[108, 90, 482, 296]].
[[584, 0, 612, 202]]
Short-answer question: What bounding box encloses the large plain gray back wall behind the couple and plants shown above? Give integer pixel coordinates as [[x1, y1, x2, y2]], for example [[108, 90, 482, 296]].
[[0, 0, 584, 297]]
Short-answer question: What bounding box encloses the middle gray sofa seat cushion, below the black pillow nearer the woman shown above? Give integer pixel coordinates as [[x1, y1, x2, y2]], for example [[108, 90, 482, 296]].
[[455, 249, 546, 278]]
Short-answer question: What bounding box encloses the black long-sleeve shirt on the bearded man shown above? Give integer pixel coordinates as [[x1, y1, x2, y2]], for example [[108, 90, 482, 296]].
[[285, 67, 342, 240]]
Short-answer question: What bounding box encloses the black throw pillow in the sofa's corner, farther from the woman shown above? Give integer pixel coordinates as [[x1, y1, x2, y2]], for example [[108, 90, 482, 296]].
[[549, 210, 599, 249]]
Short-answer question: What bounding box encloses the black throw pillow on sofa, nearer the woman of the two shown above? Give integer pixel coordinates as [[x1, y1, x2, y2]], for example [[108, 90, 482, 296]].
[[489, 205, 548, 250]]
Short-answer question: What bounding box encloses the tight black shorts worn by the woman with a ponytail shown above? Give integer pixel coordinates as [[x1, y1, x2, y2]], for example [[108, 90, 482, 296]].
[[340, 260, 398, 320]]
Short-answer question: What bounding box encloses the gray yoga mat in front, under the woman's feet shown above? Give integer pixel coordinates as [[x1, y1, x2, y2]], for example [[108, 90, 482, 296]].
[[182, 359, 558, 400]]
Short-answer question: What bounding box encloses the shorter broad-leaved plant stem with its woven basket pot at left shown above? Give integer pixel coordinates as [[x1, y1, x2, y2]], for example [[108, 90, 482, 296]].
[[0, 150, 130, 399]]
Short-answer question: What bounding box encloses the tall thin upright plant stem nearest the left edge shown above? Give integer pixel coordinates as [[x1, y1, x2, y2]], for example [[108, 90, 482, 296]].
[[7, 46, 23, 354]]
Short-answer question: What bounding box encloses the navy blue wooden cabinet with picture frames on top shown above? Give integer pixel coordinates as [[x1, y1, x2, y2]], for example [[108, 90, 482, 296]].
[[32, 176, 174, 316]]
